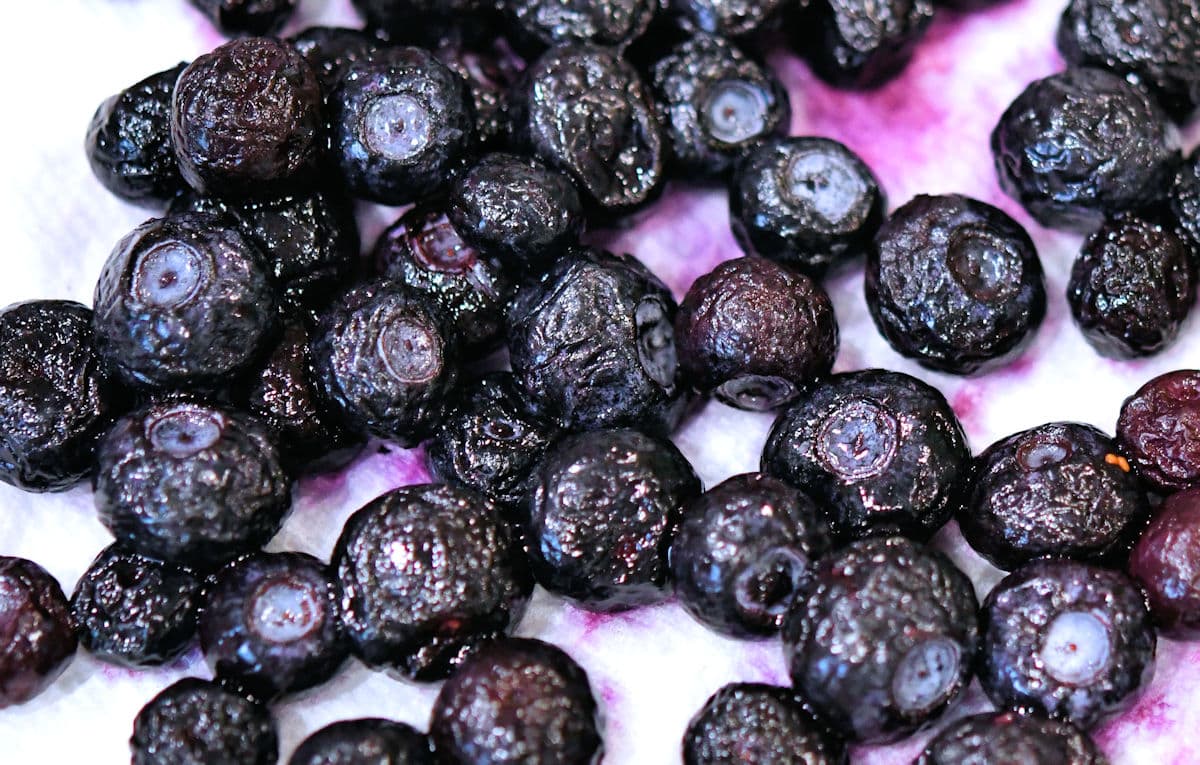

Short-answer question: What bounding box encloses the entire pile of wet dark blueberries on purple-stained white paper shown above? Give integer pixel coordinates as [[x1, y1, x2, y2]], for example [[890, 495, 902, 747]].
[[0, 0, 1200, 765]]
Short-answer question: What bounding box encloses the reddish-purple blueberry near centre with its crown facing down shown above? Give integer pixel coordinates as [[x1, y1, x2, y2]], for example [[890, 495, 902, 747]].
[[676, 257, 839, 410]]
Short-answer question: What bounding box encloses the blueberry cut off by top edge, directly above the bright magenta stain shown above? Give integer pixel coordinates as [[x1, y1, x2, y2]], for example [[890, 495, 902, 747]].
[[796, 0, 934, 90]]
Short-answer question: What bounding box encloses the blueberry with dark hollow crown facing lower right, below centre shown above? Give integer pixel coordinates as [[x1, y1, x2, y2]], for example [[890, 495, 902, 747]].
[[671, 472, 830, 638]]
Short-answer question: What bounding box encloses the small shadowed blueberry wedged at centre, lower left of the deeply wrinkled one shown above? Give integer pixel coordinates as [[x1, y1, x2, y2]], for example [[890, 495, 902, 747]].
[[425, 372, 559, 507]]
